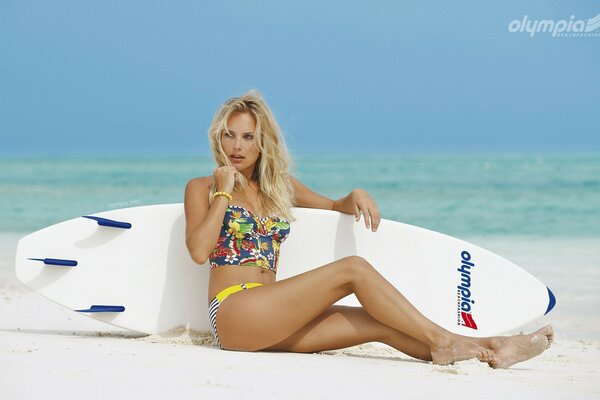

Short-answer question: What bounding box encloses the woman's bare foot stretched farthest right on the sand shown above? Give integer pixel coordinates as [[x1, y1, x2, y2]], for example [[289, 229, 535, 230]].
[[490, 325, 554, 368]]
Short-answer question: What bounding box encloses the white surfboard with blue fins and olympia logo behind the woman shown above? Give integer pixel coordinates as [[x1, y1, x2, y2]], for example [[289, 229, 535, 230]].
[[15, 203, 555, 337]]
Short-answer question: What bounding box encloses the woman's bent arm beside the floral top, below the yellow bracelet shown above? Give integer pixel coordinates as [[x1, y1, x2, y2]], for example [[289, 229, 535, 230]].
[[184, 176, 227, 265]]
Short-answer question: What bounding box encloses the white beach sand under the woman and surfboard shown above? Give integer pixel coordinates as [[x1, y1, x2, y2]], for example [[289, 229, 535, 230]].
[[0, 234, 600, 399]]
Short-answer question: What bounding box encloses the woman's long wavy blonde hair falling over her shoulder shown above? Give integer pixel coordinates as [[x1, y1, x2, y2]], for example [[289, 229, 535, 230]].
[[208, 89, 294, 221]]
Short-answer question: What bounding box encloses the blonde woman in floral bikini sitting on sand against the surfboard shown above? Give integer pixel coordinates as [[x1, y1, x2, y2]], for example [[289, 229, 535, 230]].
[[185, 91, 553, 368]]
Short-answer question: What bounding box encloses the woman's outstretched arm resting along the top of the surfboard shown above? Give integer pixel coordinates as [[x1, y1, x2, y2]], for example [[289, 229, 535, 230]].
[[291, 177, 381, 232]]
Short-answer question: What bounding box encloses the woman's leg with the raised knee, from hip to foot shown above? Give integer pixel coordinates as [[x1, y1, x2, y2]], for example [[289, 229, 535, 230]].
[[217, 256, 495, 364]]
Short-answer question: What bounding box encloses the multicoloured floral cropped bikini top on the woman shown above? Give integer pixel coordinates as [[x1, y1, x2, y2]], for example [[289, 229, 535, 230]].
[[208, 205, 290, 273]]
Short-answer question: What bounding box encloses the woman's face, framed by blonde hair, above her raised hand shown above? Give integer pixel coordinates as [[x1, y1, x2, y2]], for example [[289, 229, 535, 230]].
[[221, 112, 260, 177]]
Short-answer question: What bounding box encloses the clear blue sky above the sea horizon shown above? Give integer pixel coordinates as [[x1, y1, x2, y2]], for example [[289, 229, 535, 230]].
[[0, 0, 600, 155]]
